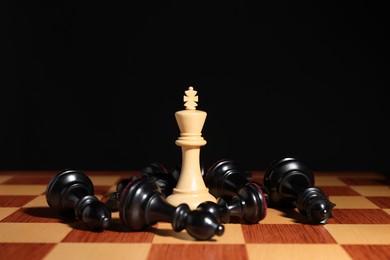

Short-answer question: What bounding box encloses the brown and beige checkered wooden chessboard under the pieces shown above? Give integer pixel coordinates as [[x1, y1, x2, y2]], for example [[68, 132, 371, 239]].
[[0, 171, 390, 260]]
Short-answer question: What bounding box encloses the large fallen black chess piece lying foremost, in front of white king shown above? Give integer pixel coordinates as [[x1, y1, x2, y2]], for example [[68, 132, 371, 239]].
[[119, 178, 224, 240]]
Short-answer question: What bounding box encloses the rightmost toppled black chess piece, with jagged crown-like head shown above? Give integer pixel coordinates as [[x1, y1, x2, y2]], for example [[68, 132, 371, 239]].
[[264, 158, 335, 224]]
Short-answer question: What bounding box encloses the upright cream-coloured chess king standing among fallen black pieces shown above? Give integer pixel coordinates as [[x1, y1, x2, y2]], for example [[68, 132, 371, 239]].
[[167, 87, 216, 210]]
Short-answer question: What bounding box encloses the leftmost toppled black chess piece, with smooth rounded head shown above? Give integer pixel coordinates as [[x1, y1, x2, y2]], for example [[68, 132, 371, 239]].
[[46, 170, 111, 229]]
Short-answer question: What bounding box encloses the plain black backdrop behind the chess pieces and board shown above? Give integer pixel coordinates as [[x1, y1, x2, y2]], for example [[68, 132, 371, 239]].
[[0, 1, 390, 172]]
